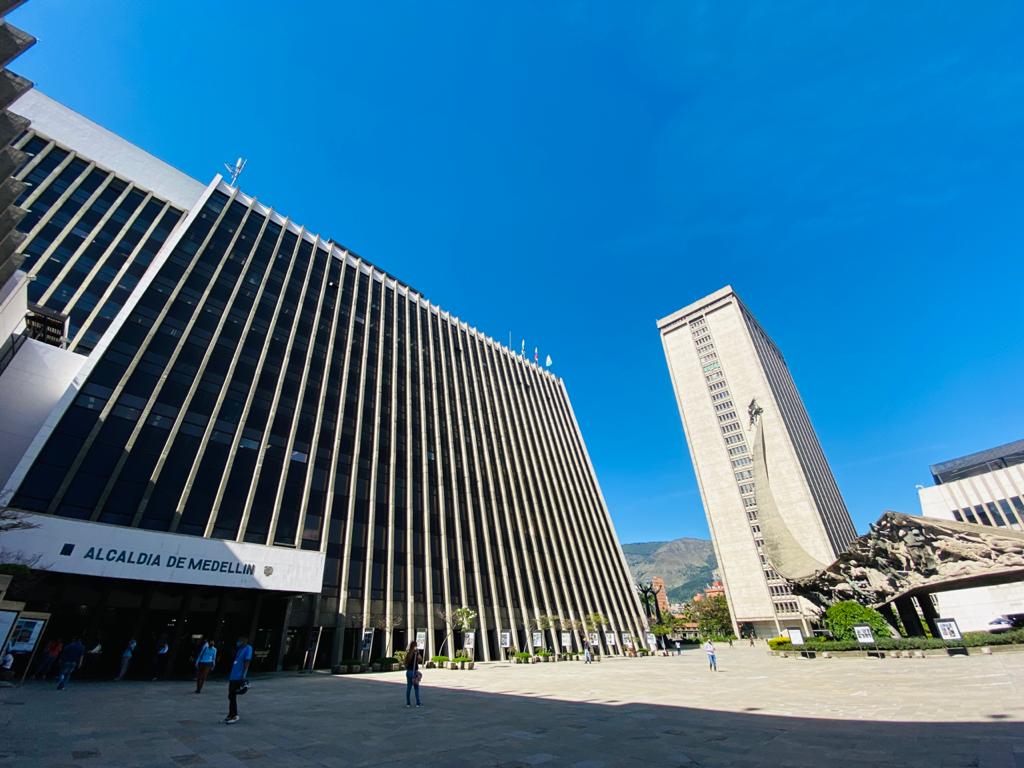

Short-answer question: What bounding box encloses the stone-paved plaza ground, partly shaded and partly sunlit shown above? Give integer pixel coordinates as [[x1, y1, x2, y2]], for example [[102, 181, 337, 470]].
[[0, 647, 1024, 768]]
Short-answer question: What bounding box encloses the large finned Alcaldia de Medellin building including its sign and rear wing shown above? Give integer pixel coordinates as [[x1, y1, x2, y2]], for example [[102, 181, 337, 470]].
[[0, 93, 647, 669]]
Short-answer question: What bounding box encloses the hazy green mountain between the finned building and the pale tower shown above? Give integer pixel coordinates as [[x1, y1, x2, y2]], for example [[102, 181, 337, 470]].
[[623, 539, 718, 602]]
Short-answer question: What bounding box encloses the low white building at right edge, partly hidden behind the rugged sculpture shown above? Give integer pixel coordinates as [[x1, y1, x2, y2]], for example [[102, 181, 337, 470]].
[[918, 440, 1024, 632]]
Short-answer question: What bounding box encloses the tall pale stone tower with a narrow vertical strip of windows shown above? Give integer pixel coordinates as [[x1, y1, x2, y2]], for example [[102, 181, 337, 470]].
[[657, 286, 856, 637]]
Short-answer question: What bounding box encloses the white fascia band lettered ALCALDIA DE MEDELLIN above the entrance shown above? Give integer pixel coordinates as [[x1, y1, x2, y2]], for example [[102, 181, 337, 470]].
[[3, 515, 324, 593]]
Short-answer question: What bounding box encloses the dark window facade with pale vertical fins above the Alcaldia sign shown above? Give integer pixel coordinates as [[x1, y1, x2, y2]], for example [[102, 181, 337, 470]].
[[14, 193, 632, 643]]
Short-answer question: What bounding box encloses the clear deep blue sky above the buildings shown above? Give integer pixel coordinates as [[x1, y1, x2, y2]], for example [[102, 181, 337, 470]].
[[11, 0, 1024, 542]]
